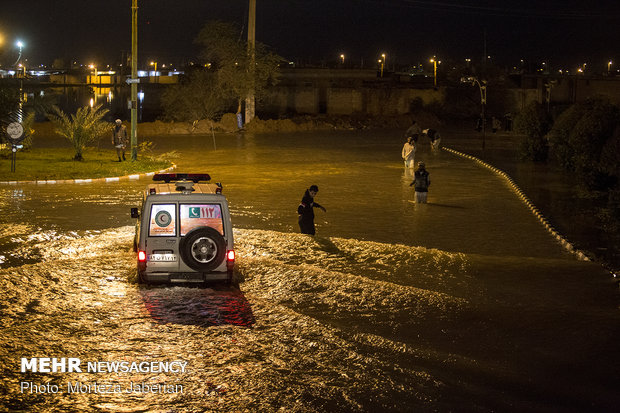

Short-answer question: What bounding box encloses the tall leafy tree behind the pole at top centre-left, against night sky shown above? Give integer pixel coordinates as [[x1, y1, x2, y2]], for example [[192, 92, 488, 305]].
[[195, 20, 283, 113]]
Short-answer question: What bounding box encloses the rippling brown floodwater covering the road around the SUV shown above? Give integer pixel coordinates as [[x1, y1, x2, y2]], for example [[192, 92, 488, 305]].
[[0, 131, 620, 412]]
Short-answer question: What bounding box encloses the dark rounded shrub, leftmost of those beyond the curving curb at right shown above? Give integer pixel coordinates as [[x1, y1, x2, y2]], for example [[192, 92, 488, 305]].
[[515, 102, 551, 162]]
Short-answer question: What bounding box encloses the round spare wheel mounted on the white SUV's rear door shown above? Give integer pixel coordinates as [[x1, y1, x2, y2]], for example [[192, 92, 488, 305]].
[[179, 227, 226, 272]]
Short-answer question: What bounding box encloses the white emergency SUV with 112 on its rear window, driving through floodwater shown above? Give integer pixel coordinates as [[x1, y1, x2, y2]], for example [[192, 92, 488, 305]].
[[131, 173, 235, 284]]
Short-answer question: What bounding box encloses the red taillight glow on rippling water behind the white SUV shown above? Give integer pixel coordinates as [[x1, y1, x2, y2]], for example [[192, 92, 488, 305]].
[[140, 287, 255, 327]]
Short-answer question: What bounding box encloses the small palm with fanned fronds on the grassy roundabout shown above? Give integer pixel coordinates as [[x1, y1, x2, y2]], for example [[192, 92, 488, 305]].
[[47, 105, 112, 161]]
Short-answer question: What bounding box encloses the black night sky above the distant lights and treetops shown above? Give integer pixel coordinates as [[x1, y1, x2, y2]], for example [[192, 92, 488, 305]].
[[0, 0, 620, 70]]
